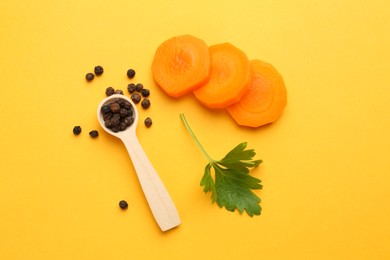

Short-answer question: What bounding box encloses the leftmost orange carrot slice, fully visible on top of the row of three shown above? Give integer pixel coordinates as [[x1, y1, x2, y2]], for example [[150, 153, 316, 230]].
[[152, 35, 210, 97]]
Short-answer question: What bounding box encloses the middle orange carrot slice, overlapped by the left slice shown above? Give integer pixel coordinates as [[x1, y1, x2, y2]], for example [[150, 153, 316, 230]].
[[194, 43, 251, 108]]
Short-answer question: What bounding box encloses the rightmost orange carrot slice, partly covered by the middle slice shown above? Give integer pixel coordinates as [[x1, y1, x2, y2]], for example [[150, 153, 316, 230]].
[[227, 60, 287, 127]]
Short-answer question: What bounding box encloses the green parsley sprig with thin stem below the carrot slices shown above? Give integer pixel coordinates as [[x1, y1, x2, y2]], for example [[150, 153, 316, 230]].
[[180, 114, 262, 217]]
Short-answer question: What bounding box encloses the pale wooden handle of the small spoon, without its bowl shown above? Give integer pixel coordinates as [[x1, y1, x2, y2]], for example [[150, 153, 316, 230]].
[[121, 133, 180, 231]]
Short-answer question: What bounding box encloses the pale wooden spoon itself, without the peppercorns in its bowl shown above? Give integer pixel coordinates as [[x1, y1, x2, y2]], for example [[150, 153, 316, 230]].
[[97, 94, 181, 231]]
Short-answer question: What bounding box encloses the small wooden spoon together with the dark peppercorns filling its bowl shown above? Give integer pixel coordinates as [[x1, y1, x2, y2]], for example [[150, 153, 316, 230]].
[[97, 94, 180, 231]]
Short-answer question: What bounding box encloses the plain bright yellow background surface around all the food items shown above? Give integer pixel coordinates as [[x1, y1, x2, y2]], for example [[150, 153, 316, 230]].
[[0, 0, 390, 260]]
